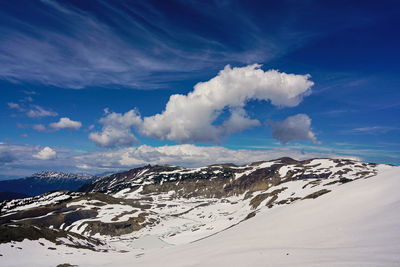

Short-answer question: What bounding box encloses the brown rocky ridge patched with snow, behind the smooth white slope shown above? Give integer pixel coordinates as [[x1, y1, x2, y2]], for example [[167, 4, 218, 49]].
[[0, 158, 399, 265]]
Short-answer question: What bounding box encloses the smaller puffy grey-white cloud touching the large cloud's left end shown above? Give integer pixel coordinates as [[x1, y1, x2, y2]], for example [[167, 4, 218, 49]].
[[89, 109, 141, 148]]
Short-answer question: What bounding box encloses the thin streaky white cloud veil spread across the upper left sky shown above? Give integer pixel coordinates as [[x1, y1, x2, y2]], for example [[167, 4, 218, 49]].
[[0, 1, 316, 89]]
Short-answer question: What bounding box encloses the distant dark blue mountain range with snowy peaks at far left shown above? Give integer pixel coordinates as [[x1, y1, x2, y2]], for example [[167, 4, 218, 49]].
[[0, 171, 98, 201]]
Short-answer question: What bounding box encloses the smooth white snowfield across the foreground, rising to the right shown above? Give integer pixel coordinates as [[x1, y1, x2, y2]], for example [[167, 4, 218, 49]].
[[0, 165, 400, 267]]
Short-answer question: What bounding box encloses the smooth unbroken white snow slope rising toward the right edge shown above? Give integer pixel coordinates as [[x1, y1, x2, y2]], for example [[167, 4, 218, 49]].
[[130, 167, 400, 266]]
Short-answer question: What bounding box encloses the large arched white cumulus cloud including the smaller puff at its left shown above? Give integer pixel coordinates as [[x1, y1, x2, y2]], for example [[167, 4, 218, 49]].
[[89, 64, 313, 147]]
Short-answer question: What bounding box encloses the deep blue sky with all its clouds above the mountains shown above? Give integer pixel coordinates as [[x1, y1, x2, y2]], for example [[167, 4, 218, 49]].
[[0, 0, 400, 179]]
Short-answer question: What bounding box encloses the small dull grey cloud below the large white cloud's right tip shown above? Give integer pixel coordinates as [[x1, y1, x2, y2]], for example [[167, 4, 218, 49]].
[[270, 114, 320, 144]]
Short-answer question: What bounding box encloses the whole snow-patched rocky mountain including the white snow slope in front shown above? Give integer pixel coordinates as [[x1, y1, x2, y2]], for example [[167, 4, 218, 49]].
[[0, 158, 400, 266]]
